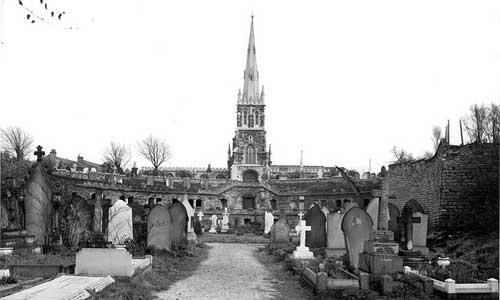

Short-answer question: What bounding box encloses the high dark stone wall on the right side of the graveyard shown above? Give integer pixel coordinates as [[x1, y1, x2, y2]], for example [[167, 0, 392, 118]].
[[382, 142, 499, 228]]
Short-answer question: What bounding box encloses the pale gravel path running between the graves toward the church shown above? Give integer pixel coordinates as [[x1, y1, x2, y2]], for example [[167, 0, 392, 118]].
[[157, 243, 298, 300]]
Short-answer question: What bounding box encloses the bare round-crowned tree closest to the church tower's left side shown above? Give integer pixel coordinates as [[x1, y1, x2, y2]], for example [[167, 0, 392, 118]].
[[137, 135, 172, 175]]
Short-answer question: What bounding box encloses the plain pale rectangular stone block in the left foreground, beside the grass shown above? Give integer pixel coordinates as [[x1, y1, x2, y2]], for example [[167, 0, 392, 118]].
[[75, 248, 134, 277]]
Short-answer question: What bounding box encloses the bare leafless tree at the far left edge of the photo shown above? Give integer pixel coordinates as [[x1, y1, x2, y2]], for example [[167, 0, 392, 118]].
[[1, 127, 33, 160]]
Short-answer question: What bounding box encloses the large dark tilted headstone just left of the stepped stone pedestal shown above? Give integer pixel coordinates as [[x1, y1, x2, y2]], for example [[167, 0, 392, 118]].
[[342, 207, 373, 269]]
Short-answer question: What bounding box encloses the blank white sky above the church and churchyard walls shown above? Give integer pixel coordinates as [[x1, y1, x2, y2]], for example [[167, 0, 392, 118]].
[[0, 0, 500, 172]]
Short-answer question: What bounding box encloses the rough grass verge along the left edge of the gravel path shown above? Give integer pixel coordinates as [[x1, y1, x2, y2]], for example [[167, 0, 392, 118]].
[[94, 242, 209, 300]]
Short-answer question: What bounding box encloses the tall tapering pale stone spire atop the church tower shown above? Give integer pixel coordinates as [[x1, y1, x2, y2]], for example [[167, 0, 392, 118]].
[[238, 15, 263, 104]]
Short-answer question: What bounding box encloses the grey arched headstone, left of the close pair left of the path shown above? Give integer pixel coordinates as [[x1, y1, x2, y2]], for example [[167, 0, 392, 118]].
[[148, 202, 172, 250]]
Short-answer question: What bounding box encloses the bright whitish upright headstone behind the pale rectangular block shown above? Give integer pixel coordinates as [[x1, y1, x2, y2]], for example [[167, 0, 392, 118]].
[[108, 200, 134, 245]]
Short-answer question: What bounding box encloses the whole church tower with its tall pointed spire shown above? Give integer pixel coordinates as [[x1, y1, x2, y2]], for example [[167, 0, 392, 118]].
[[228, 16, 271, 182]]
